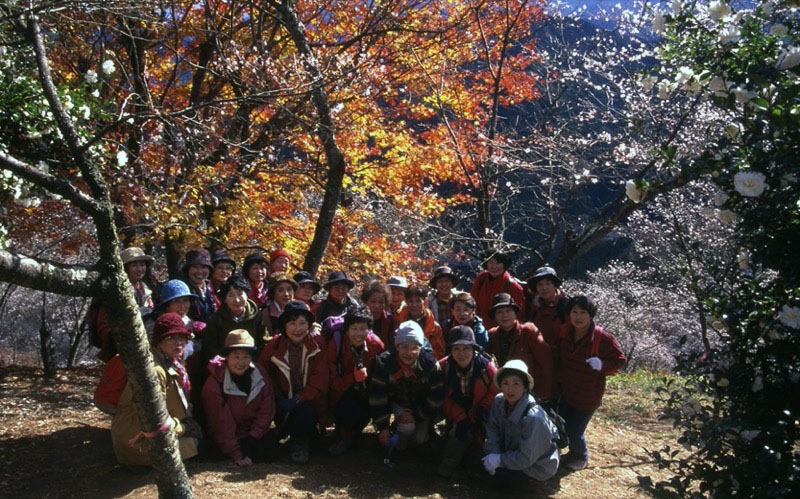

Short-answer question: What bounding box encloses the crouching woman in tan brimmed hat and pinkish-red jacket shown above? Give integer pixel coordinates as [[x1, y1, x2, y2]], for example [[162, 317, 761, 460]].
[[203, 329, 277, 466]]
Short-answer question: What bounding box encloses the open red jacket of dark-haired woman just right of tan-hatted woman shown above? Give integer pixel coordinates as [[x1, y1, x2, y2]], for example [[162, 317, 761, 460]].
[[258, 334, 328, 406]]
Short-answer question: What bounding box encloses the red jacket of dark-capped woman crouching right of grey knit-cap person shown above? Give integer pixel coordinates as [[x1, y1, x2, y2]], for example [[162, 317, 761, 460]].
[[439, 356, 500, 424]]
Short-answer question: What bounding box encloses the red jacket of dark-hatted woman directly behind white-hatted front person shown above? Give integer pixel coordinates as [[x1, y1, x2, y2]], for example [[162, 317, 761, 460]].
[[489, 321, 556, 401]]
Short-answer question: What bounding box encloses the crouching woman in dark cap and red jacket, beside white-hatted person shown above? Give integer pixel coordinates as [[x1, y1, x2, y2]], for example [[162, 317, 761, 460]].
[[438, 326, 498, 478]]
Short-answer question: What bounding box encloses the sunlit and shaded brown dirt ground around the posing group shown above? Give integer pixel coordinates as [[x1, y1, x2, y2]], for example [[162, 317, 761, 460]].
[[0, 367, 673, 499]]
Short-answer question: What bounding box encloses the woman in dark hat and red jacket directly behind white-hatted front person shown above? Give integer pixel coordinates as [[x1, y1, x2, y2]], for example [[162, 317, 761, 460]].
[[489, 293, 556, 404]]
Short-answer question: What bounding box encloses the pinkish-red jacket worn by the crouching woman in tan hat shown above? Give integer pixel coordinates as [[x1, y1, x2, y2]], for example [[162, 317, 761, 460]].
[[203, 356, 275, 461]]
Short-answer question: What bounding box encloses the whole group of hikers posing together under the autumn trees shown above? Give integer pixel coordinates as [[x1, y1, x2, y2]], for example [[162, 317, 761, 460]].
[[97, 248, 626, 484]]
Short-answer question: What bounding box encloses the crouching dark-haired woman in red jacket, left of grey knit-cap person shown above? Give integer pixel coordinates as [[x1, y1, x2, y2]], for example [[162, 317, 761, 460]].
[[327, 307, 384, 456]]
